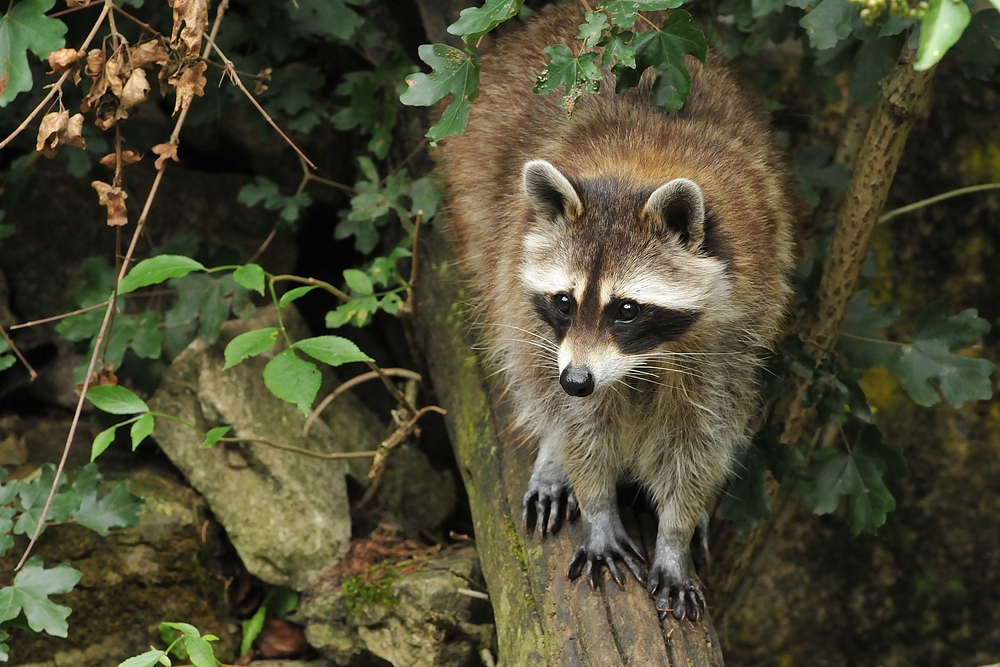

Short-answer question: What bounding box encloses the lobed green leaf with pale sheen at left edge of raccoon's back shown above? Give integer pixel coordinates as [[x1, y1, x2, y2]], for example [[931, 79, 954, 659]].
[[399, 44, 479, 143]]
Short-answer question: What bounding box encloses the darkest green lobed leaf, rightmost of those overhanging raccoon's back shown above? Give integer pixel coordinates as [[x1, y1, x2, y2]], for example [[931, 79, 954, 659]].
[[632, 10, 708, 112]]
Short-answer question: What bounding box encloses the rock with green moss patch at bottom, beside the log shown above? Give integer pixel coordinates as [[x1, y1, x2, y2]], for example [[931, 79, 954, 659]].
[[293, 547, 494, 667]]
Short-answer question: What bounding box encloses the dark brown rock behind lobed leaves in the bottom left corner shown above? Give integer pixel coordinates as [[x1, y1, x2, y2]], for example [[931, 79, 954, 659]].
[[0, 469, 239, 667]]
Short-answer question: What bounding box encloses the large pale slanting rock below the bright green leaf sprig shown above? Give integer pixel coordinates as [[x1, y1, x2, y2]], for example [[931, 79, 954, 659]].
[[149, 308, 375, 590]]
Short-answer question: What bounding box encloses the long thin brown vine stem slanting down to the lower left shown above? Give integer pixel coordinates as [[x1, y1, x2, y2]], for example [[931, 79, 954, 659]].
[[14, 0, 229, 572]]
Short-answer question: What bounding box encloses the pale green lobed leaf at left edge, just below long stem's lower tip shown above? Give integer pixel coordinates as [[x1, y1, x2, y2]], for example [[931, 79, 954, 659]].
[[0, 556, 81, 637]]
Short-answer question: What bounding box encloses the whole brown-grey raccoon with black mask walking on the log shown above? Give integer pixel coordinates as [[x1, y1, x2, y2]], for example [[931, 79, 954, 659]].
[[441, 3, 794, 620]]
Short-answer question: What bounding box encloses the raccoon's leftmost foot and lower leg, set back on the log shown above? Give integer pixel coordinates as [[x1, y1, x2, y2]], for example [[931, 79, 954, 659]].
[[521, 438, 580, 537]]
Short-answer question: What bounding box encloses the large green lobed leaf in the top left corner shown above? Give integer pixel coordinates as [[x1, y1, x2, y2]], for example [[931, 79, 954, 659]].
[[0, 0, 66, 107]]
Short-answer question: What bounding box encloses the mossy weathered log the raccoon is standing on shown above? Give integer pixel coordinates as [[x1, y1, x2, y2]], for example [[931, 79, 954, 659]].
[[415, 233, 723, 667]]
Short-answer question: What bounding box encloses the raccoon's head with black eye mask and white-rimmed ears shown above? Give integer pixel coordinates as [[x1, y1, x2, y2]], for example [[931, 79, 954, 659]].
[[521, 160, 730, 396]]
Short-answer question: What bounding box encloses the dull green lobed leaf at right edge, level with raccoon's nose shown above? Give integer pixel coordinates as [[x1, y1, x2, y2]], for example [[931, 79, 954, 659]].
[[885, 302, 995, 408]]
